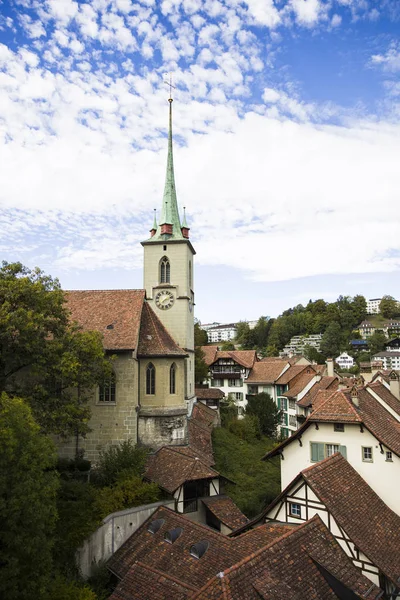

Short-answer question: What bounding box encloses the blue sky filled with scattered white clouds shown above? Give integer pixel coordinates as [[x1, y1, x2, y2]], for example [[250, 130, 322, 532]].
[[0, 0, 400, 323]]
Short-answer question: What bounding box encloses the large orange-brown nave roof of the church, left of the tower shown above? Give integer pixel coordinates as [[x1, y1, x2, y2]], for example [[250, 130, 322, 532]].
[[65, 290, 145, 350]]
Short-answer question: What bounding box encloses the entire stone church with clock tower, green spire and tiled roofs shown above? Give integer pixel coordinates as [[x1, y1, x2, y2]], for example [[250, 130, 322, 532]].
[[58, 98, 195, 460]]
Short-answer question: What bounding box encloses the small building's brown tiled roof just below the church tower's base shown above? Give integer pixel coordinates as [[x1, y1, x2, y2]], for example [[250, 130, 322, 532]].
[[144, 446, 219, 494]]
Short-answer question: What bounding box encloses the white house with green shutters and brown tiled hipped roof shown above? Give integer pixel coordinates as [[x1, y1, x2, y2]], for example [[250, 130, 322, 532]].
[[264, 371, 400, 515]]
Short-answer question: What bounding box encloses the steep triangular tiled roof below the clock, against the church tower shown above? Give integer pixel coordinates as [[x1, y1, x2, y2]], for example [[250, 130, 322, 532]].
[[137, 302, 187, 357]]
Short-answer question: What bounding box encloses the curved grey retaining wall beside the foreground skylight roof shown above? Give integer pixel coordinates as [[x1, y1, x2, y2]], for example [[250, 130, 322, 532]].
[[76, 500, 175, 579]]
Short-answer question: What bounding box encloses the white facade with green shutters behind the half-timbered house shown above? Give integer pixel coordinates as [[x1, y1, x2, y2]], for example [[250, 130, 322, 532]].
[[281, 422, 400, 515]]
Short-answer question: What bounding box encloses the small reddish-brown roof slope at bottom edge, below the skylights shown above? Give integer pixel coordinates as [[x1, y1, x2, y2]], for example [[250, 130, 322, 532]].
[[109, 562, 196, 600]]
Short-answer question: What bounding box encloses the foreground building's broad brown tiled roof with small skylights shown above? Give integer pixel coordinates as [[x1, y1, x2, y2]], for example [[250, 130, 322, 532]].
[[107, 507, 382, 600]]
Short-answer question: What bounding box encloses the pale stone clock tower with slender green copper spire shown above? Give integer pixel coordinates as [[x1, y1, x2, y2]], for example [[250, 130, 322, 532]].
[[142, 98, 195, 426]]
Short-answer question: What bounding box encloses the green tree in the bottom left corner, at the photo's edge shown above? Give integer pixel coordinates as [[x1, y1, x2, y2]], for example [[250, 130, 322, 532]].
[[0, 393, 58, 600]]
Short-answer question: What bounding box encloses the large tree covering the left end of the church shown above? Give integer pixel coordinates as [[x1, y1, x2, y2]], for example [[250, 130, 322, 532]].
[[0, 263, 111, 435]]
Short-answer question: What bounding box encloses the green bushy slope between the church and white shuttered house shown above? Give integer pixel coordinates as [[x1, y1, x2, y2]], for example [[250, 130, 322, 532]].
[[213, 426, 280, 518]]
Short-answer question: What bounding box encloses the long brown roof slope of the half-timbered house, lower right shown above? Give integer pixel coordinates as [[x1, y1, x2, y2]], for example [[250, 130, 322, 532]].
[[302, 454, 400, 585]]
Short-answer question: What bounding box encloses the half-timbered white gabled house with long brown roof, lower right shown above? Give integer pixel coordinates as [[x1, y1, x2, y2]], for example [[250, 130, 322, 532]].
[[242, 453, 400, 598]]
